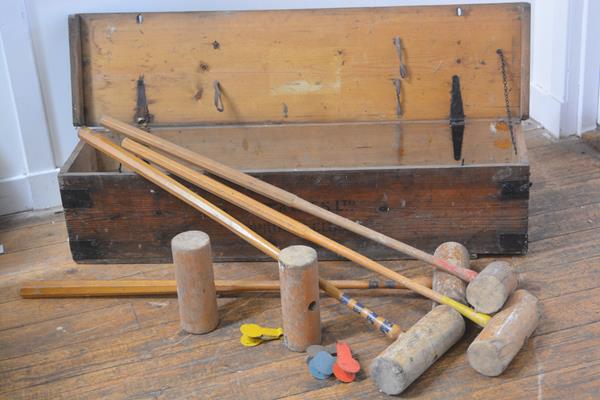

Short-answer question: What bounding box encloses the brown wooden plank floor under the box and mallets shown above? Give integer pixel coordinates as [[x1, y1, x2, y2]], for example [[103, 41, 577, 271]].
[[0, 126, 600, 399]]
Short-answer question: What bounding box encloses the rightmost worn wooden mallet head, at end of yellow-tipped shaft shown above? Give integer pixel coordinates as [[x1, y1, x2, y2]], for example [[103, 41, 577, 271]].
[[467, 289, 541, 376]]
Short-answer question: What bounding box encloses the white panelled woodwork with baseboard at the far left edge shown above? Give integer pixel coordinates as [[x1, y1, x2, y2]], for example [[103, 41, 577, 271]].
[[0, 0, 60, 215]]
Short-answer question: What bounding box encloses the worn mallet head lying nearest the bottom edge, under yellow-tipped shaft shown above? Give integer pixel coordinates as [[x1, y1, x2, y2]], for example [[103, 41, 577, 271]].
[[371, 305, 465, 394]]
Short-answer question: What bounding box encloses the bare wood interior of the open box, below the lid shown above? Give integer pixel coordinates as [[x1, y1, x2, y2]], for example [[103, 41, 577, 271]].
[[63, 120, 527, 173]]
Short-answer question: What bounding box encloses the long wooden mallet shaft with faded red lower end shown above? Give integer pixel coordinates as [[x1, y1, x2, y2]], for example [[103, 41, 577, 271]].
[[100, 116, 477, 282]]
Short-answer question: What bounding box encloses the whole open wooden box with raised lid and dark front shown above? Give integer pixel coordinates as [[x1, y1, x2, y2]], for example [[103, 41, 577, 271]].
[[59, 4, 530, 263]]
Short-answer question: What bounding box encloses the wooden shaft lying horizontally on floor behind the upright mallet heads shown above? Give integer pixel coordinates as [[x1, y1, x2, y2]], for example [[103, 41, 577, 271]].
[[19, 277, 431, 299]]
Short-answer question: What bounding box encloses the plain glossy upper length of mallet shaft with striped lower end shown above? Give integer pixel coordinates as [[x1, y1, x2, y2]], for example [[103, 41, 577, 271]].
[[79, 128, 404, 339]]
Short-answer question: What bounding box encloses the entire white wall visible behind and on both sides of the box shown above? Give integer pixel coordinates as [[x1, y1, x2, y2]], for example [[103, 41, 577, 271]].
[[0, 0, 600, 214]]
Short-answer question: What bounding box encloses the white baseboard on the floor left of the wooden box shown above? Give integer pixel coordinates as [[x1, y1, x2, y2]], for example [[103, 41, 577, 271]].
[[0, 169, 61, 215]]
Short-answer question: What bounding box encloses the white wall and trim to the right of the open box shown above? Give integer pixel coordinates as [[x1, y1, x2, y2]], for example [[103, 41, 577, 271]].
[[530, 0, 600, 137]]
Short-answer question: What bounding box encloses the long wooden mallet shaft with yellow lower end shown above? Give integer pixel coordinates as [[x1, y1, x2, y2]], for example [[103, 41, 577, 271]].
[[122, 139, 489, 326]]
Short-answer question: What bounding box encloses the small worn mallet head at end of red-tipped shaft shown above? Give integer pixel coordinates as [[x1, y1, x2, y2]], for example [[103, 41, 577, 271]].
[[466, 261, 518, 314]]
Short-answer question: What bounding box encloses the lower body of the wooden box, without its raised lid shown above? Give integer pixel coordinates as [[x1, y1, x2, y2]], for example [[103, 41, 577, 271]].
[[59, 121, 529, 263]]
